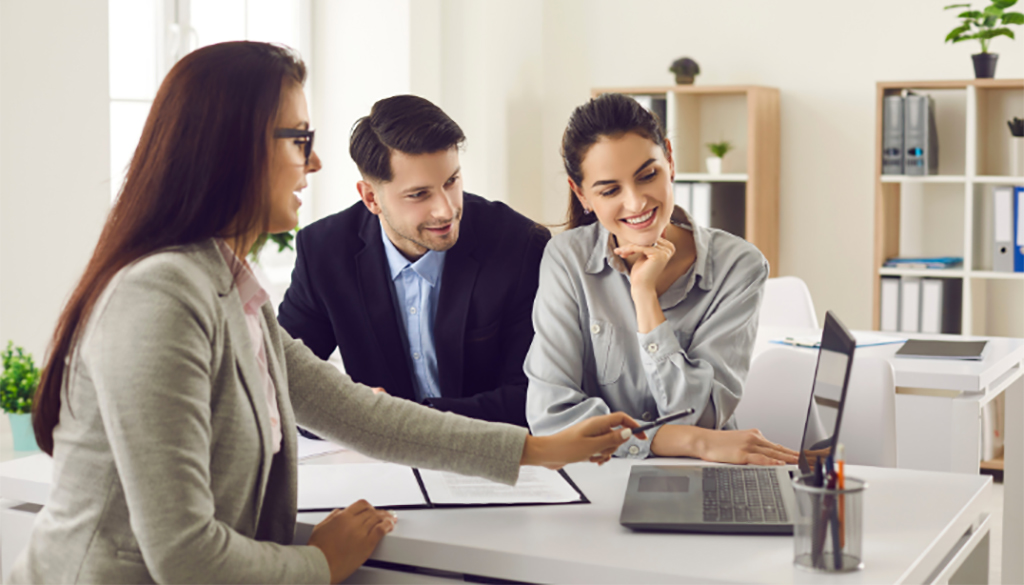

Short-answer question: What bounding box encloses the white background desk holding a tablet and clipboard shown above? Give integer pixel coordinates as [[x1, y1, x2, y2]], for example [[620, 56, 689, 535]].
[[754, 328, 1024, 583]]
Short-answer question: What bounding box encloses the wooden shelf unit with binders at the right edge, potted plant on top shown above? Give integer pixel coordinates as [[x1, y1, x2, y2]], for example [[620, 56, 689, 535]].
[[872, 79, 1024, 337]]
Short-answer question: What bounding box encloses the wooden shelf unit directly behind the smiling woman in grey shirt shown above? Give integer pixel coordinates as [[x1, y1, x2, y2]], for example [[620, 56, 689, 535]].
[[591, 85, 780, 277]]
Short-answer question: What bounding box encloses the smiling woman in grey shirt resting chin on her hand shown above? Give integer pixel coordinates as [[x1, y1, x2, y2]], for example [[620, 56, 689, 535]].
[[524, 94, 796, 464]]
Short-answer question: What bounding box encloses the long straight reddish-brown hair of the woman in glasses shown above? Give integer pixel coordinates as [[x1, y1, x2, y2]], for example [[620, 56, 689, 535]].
[[32, 42, 306, 455]]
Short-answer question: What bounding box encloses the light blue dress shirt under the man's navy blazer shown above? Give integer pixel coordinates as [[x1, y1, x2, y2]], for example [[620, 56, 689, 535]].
[[381, 224, 447, 402]]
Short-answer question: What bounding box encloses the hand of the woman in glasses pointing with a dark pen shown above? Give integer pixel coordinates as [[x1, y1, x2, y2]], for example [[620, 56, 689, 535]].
[[519, 412, 646, 469]]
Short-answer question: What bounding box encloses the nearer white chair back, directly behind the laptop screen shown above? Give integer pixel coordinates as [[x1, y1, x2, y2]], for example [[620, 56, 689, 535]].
[[735, 347, 897, 467]]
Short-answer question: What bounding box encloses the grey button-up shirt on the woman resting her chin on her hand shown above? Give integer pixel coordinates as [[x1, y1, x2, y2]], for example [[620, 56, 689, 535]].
[[524, 207, 768, 459]]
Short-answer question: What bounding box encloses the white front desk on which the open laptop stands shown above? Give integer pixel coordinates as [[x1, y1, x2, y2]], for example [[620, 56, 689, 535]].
[[299, 459, 991, 583]]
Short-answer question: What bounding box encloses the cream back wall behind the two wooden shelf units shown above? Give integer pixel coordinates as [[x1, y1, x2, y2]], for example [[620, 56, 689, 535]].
[[428, 0, 1024, 329]]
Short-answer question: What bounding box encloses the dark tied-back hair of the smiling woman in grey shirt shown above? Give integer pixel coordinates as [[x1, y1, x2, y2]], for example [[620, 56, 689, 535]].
[[562, 93, 669, 229]]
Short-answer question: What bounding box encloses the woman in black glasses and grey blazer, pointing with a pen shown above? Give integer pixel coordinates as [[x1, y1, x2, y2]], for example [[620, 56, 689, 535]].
[[11, 42, 636, 583]]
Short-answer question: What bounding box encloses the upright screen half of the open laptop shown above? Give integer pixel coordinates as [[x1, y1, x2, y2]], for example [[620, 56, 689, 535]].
[[800, 311, 857, 474]]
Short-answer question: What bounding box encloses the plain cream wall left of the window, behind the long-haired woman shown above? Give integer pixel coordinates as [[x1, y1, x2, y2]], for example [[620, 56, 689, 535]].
[[0, 0, 111, 364]]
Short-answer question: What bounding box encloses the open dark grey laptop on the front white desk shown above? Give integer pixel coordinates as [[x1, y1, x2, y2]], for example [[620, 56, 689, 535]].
[[618, 311, 857, 534]]
